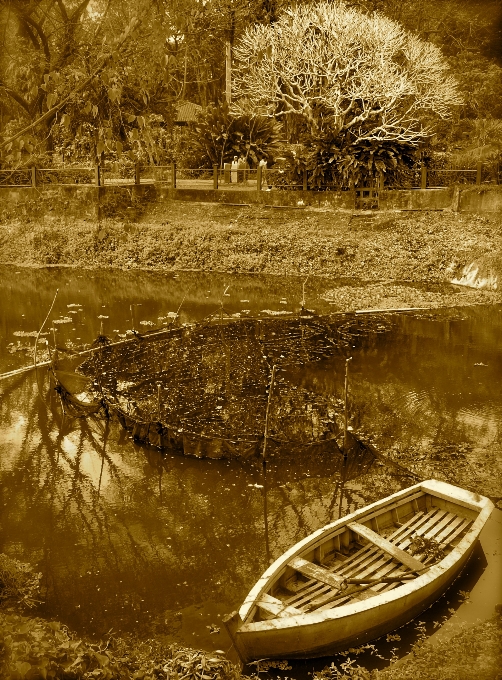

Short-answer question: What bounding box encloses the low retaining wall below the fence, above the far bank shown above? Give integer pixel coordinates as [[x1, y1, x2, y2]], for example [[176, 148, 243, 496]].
[[0, 184, 502, 221]]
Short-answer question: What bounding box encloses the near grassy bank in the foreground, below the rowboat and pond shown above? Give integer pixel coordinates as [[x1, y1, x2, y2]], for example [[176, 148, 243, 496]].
[[0, 610, 502, 680]]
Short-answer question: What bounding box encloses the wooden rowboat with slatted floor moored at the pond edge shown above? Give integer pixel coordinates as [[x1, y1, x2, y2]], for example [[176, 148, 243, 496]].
[[225, 480, 493, 662]]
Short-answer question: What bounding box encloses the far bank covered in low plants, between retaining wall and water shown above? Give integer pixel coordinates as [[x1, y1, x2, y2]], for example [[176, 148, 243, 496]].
[[0, 202, 502, 309]]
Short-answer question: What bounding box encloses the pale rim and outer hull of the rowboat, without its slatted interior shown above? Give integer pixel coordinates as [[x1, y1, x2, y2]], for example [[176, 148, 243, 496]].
[[226, 480, 493, 662]]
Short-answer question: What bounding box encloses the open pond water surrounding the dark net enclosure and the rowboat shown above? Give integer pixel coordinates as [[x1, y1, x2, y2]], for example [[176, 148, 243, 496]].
[[0, 267, 502, 678]]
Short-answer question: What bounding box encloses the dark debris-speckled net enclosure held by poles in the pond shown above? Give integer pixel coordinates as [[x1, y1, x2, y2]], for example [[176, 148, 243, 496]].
[[53, 313, 392, 459]]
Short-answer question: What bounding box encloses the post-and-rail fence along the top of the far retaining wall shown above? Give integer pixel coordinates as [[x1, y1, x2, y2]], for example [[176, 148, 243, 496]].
[[0, 162, 502, 191]]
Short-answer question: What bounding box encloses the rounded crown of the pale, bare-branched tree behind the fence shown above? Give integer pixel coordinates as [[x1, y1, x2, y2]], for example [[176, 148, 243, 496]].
[[233, 1, 461, 183]]
